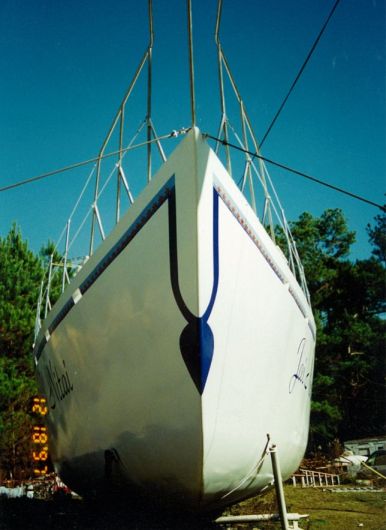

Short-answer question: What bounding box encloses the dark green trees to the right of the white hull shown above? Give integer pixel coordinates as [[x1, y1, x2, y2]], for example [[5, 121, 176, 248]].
[[280, 209, 386, 451]]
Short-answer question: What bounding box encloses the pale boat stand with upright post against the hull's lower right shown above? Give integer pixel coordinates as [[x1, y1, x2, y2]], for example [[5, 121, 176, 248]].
[[215, 445, 308, 530]]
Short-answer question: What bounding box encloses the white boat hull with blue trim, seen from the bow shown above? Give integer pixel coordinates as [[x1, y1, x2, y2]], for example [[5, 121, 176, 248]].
[[35, 129, 315, 511]]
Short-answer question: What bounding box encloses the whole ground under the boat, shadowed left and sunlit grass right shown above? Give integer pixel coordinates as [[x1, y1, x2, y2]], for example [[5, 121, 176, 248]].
[[0, 486, 386, 530]]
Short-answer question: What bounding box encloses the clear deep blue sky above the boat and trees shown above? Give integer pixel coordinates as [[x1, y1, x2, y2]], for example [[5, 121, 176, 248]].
[[0, 0, 386, 259]]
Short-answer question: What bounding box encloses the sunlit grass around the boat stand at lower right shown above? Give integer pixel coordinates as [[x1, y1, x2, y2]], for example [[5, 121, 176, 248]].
[[223, 485, 386, 530]]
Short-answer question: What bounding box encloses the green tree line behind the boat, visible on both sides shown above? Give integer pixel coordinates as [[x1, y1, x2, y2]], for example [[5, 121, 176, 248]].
[[0, 209, 386, 479]]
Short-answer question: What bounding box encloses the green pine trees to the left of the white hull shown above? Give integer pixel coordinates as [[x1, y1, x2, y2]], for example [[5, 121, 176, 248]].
[[0, 225, 43, 477]]
